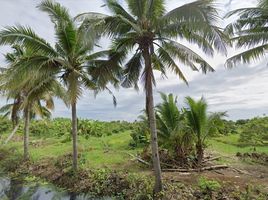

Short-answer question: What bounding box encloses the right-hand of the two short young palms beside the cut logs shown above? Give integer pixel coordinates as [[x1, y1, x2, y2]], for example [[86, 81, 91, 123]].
[[185, 97, 226, 166]]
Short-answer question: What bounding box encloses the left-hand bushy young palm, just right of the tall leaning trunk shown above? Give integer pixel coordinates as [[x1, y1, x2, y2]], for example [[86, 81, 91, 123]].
[[156, 93, 193, 164]]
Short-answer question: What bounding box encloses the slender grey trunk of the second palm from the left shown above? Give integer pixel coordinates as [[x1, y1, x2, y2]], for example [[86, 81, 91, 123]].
[[72, 103, 78, 172]]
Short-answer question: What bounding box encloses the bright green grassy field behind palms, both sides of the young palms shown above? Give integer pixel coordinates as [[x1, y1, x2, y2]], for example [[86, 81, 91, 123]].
[[1, 131, 268, 171]]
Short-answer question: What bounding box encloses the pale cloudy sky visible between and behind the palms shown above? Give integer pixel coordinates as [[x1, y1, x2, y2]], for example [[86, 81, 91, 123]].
[[0, 0, 268, 120]]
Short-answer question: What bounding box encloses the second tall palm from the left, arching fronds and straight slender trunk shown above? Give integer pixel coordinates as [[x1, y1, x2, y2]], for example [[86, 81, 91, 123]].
[[0, 0, 118, 171]]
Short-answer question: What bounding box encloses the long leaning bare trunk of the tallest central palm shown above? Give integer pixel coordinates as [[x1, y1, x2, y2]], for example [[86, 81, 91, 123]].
[[143, 49, 162, 193]]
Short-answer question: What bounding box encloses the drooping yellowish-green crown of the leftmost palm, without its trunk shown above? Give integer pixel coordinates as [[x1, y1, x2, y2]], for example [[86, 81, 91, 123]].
[[0, 45, 64, 122]]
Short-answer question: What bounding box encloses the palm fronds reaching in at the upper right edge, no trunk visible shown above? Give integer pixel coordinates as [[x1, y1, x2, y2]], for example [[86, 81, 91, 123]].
[[226, 0, 268, 67]]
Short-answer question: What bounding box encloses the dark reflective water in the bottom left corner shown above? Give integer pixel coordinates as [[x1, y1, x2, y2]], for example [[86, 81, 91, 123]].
[[0, 176, 111, 200]]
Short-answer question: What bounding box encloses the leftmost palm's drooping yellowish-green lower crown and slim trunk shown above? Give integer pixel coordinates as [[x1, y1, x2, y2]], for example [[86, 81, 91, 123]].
[[1, 64, 60, 160]]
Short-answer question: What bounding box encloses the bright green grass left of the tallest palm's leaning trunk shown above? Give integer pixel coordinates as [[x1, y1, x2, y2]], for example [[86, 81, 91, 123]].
[[1, 131, 141, 170]]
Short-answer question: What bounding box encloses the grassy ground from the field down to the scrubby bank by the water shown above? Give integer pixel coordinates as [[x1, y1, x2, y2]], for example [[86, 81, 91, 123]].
[[0, 131, 268, 200]]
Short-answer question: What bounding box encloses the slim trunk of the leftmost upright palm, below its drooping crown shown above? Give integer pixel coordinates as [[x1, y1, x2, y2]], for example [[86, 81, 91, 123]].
[[23, 106, 30, 160]]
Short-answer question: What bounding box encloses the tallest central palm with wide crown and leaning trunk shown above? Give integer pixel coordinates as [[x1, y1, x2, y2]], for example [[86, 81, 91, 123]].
[[78, 0, 228, 193]]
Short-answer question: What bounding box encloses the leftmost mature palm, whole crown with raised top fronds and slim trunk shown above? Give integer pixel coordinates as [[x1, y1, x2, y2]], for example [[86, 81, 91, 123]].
[[0, 45, 64, 160]]
